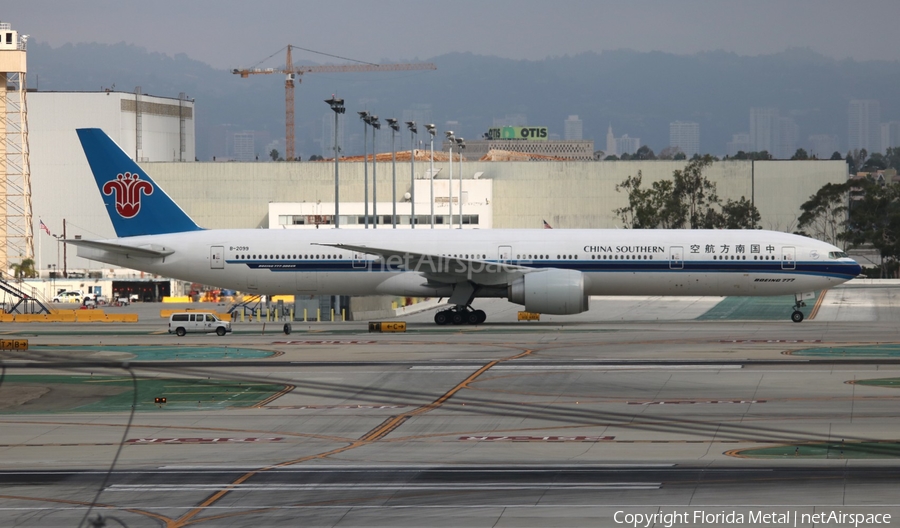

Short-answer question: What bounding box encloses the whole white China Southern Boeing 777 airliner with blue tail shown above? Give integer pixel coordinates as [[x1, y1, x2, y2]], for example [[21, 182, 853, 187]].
[[72, 129, 860, 324]]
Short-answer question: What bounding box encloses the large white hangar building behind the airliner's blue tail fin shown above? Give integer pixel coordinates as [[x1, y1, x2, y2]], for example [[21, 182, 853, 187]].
[[27, 91, 195, 270]]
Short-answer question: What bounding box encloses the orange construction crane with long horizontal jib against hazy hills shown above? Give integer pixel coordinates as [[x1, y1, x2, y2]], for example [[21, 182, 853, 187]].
[[231, 44, 437, 160]]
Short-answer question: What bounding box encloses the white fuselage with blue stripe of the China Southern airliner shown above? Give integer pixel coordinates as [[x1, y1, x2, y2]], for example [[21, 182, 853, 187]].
[[78, 228, 860, 297]]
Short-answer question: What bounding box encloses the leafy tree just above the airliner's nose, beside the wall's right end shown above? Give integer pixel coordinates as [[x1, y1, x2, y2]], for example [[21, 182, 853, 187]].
[[797, 181, 852, 249]]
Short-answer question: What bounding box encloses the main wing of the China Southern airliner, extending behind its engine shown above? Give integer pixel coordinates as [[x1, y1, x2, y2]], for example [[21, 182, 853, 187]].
[[316, 244, 540, 286]]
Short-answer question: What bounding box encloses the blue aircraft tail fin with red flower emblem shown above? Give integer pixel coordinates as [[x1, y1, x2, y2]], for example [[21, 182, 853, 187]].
[[77, 128, 201, 237]]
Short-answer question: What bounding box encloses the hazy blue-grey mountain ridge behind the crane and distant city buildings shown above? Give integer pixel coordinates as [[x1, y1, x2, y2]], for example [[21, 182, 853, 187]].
[[22, 40, 900, 159]]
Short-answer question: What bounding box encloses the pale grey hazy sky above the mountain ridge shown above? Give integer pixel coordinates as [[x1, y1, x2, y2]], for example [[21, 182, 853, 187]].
[[7, 0, 900, 68]]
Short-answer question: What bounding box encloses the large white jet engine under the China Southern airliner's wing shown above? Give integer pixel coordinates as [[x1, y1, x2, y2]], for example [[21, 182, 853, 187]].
[[507, 269, 588, 315]]
